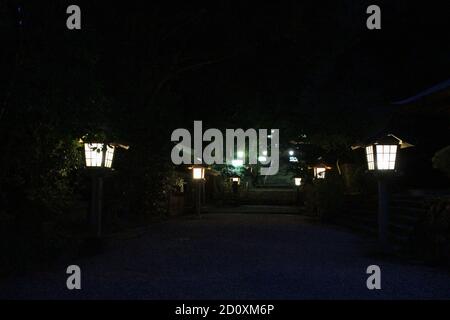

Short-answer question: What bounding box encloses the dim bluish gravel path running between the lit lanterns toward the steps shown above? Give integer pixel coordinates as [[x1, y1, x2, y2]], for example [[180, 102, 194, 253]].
[[0, 213, 450, 299]]
